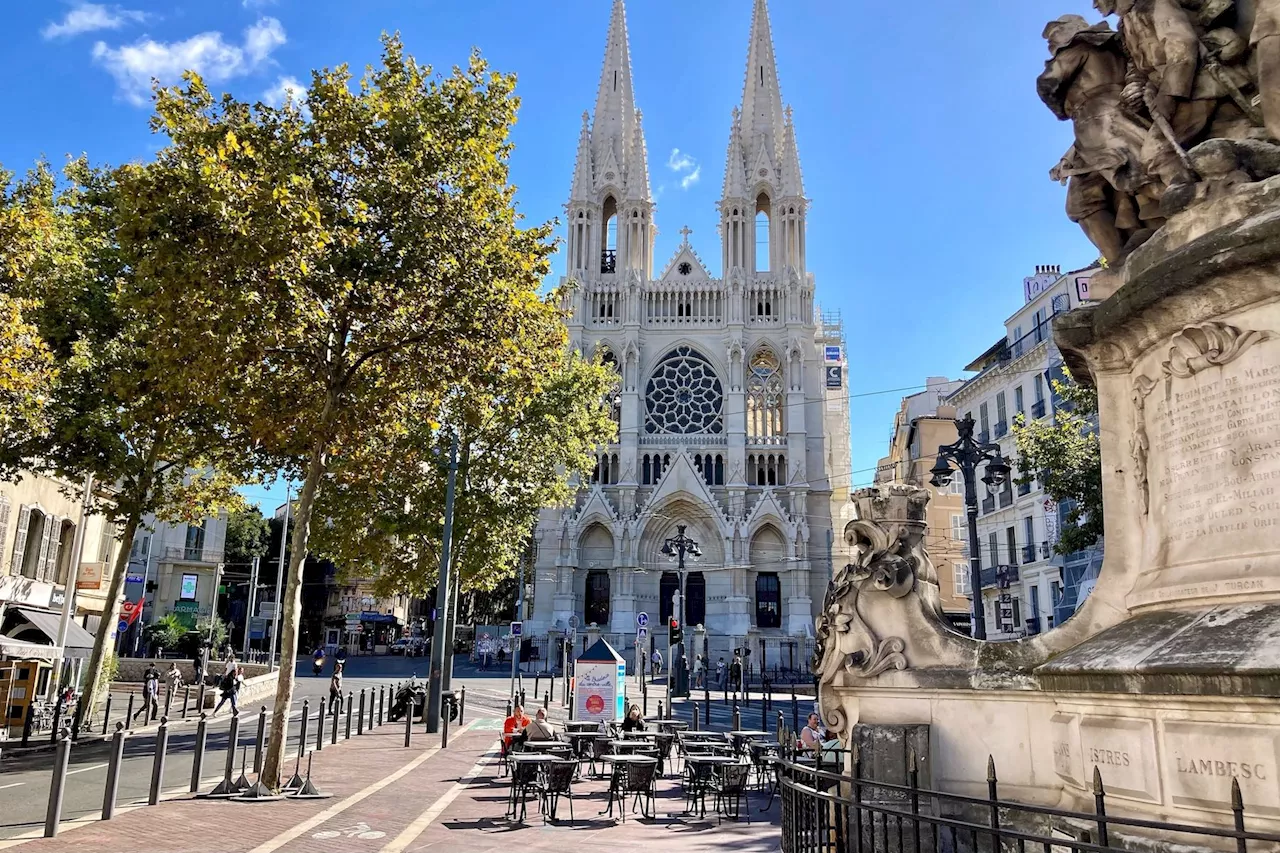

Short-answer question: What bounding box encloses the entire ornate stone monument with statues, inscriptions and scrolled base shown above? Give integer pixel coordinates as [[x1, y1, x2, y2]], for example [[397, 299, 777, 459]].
[[813, 0, 1280, 831]]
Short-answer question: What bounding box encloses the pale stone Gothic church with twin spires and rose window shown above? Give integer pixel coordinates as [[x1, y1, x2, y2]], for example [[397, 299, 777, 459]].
[[526, 0, 850, 669]]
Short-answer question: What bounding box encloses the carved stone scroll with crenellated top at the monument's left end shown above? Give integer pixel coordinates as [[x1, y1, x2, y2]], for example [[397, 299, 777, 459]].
[[812, 484, 937, 691]]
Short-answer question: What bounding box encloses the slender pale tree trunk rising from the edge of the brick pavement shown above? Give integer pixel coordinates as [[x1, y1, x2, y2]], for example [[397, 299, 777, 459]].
[[260, 392, 335, 792]]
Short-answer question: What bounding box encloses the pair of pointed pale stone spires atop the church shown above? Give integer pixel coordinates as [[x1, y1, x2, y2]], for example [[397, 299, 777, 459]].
[[567, 0, 806, 280]]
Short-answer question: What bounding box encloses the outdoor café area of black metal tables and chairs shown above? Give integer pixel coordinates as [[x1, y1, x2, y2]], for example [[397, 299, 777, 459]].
[[499, 717, 780, 825]]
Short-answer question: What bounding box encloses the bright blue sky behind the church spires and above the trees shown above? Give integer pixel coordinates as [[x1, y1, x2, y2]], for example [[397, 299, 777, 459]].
[[0, 0, 1097, 506]]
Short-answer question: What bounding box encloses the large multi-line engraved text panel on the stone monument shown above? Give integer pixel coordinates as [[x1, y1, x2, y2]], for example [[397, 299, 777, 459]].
[[1146, 341, 1280, 571]]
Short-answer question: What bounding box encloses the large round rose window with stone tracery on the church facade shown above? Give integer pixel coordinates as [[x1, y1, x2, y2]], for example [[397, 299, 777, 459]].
[[645, 347, 724, 435]]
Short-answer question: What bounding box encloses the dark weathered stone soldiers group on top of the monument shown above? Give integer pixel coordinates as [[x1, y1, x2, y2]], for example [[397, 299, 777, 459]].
[[1037, 0, 1280, 265]]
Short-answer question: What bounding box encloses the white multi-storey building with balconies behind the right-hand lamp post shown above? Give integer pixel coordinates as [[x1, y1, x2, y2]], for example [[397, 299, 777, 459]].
[[947, 265, 1102, 639]]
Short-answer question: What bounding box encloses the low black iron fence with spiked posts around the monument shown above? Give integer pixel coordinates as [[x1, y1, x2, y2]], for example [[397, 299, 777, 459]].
[[776, 751, 1280, 853]]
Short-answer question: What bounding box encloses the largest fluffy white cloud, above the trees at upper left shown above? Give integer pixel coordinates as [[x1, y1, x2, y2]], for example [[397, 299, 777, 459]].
[[93, 18, 287, 106]]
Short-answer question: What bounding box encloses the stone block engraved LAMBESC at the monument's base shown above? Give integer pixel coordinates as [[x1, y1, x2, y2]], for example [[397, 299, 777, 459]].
[[1165, 722, 1280, 815]]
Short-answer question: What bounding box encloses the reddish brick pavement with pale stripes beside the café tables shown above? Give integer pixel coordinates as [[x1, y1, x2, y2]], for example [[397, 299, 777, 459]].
[[0, 720, 778, 853]]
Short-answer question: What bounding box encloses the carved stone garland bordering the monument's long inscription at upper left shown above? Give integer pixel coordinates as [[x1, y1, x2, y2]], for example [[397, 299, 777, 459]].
[[1129, 323, 1275, 515]]
